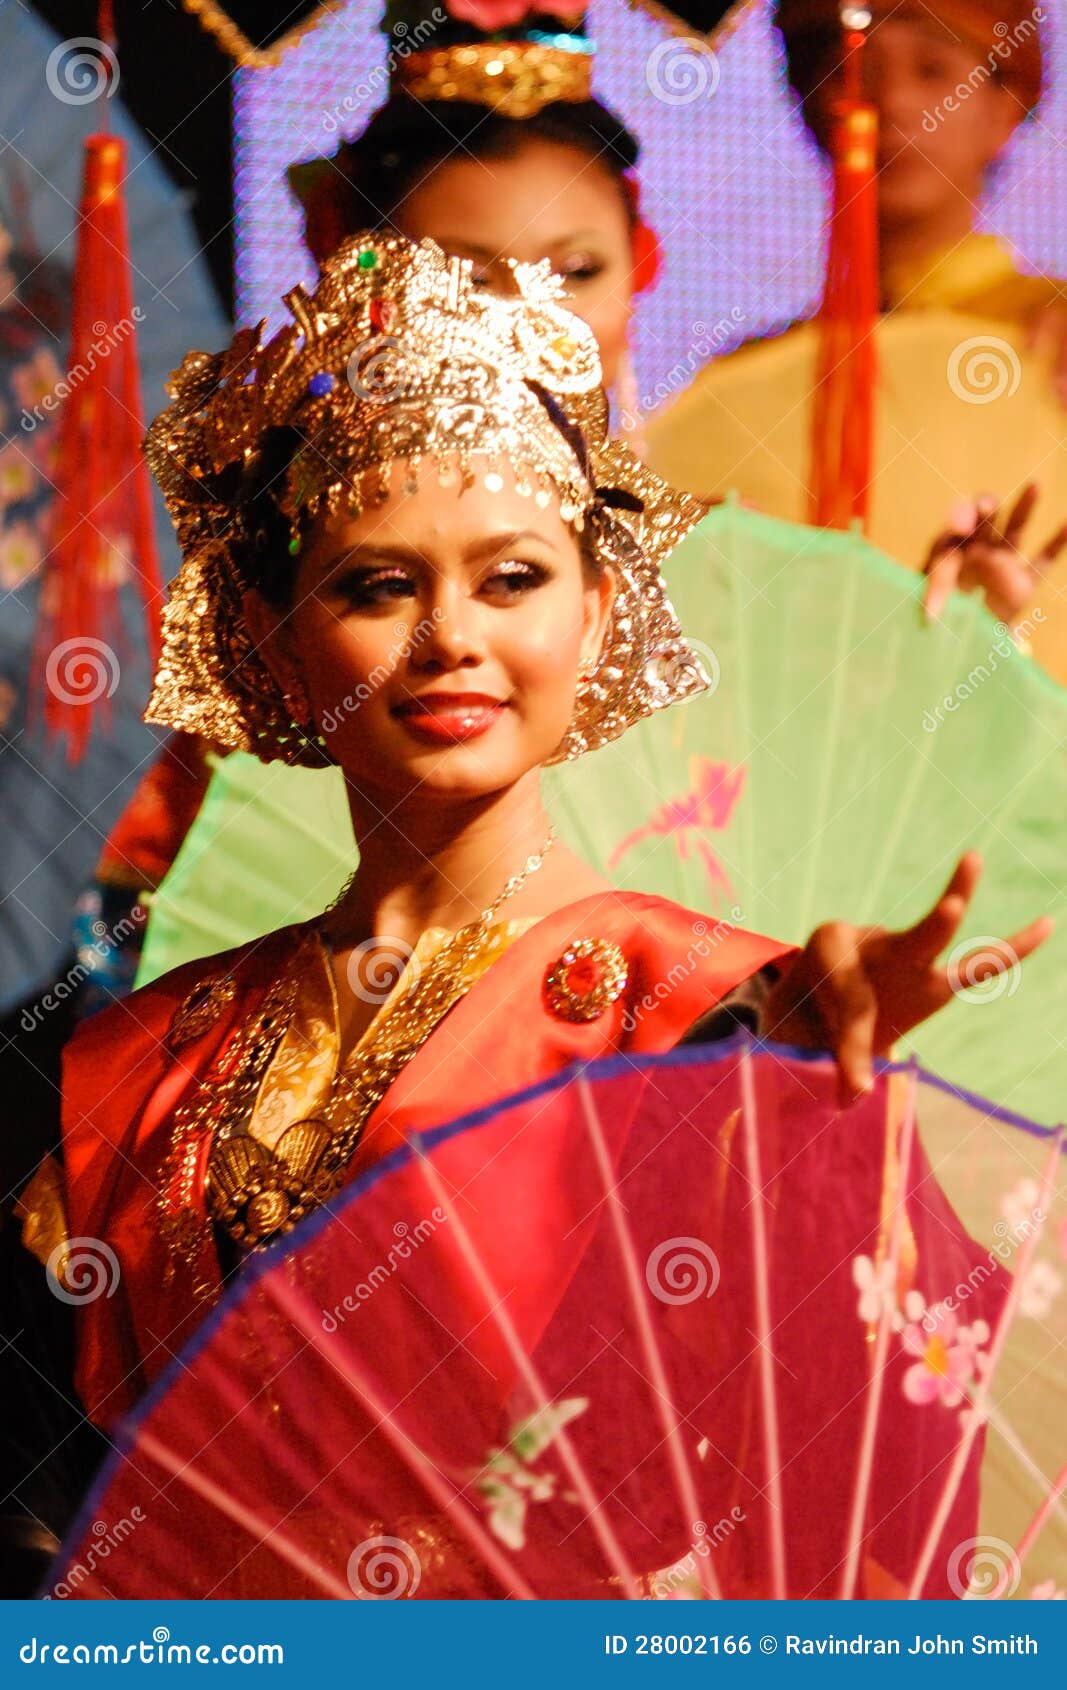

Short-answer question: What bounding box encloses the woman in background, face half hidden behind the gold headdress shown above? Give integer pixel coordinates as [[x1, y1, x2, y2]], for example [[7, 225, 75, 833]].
[[106, 0, 659, 1000]]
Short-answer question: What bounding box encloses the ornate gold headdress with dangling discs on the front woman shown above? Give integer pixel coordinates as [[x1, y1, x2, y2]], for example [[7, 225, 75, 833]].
[[145, 235, 709, 764]]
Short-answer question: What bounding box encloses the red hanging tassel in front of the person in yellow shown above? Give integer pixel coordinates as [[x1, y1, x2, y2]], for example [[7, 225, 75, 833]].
[[808, 18, 879, 529]]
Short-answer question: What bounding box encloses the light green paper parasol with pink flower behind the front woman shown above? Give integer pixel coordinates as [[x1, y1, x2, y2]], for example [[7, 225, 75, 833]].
[[140, 504, 1067, 1124]]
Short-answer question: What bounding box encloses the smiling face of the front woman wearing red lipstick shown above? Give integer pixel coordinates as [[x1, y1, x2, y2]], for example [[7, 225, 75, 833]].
[[240, 465, 614, 801]]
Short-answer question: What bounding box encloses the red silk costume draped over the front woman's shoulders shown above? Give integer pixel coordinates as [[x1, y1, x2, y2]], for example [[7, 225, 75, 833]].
[[64, 892, 788, 1426]]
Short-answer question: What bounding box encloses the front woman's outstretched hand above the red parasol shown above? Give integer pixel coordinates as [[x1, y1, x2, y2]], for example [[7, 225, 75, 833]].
[[764, 852, 1052, 1105]]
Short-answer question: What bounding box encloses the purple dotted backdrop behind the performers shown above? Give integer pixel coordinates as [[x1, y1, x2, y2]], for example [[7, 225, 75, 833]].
[[237, 0, 1067, 402]]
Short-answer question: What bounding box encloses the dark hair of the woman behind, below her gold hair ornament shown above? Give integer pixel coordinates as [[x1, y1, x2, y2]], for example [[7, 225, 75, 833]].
[[289, 93, 639, 264]]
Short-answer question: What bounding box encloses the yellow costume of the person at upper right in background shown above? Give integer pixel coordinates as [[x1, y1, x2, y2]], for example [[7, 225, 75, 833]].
[[648, 235, 1067, 683]]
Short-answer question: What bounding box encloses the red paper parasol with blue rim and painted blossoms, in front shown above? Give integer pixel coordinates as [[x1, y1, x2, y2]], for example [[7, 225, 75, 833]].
[[49, 1043, 1064, 1599]]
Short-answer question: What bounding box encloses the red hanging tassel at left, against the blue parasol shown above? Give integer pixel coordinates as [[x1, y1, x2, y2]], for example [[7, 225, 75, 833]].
[[36, 94, 162, 762]]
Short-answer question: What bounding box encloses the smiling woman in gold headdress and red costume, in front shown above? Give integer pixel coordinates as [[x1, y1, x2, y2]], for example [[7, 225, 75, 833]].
[[31, 235, 1047, 1595]]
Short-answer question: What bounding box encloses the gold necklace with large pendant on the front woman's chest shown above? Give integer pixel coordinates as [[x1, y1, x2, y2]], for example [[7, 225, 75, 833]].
[[205, 830, 556, 1251]]
